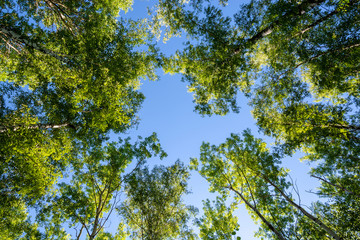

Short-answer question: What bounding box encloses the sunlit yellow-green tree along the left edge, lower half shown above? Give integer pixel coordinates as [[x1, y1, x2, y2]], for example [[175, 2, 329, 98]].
[[0, 84, 76, 239]]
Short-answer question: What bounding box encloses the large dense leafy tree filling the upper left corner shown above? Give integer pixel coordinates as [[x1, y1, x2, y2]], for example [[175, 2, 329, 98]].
[[0, 1, 157, 142]]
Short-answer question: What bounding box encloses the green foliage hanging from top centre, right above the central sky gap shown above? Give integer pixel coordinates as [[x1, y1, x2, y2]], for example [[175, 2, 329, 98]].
[[161, 1, 251, 115]]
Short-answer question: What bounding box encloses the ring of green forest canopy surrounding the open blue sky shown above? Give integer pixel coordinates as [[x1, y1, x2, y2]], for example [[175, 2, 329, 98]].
[[0, 0, 360, 240]]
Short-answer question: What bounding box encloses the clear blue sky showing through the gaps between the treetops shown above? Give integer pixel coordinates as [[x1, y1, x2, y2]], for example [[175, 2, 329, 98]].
[[109, 0, 316, 240]]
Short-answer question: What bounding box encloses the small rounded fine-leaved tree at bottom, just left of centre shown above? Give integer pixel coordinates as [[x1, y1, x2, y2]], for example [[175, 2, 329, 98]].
[[119, 161, 196, 240]]
